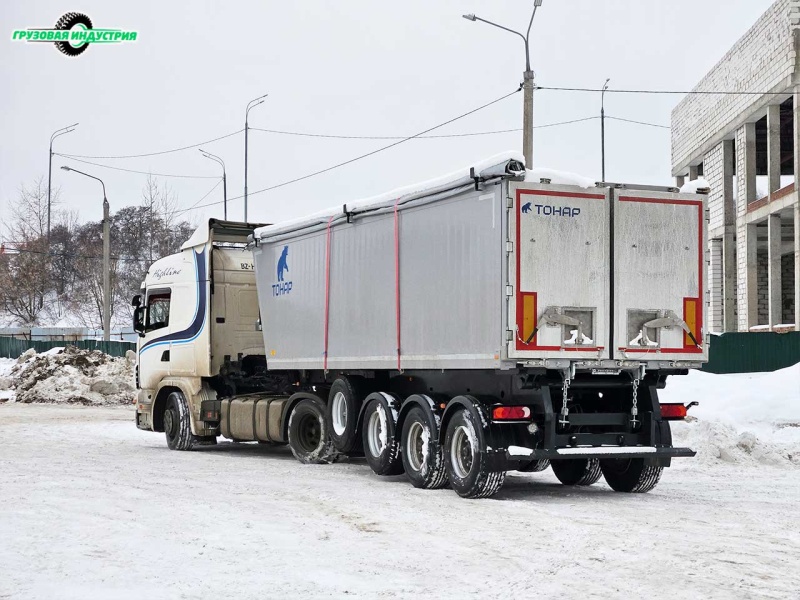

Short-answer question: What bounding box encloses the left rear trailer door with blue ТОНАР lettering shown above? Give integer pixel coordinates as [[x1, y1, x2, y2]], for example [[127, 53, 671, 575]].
[[507, 183, 610, 359]]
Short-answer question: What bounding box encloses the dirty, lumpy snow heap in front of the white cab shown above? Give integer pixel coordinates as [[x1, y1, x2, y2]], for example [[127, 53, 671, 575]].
[[0, 346, 136, 405]]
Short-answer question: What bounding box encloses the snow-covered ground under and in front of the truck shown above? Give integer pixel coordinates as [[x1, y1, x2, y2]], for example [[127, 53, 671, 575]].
[[0, 404, 800, 600]]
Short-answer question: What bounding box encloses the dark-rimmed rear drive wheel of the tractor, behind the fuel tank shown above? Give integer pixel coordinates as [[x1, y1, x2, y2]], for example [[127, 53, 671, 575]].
[[289, 398, 339, 465]]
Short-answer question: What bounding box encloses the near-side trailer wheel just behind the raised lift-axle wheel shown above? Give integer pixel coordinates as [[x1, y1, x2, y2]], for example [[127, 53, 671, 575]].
[[361, 394, 403, 475]]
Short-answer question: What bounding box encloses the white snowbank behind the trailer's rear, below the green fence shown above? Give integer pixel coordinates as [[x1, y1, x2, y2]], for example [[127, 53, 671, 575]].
[[660, 363, 800, 466]]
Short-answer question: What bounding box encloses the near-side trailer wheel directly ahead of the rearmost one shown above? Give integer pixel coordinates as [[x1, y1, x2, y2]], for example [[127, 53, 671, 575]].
[[400, 406, 448, 490]]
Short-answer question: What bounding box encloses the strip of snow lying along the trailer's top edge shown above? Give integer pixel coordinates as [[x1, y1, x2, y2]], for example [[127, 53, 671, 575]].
[[255, 151, 595, 239]]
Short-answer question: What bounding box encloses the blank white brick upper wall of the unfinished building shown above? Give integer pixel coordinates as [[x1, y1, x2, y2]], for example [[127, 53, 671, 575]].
[[672, 0, 800, 173]]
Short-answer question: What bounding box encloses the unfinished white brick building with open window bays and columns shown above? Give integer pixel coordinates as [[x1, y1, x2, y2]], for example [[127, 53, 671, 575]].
[[672, 0, 800, 332]]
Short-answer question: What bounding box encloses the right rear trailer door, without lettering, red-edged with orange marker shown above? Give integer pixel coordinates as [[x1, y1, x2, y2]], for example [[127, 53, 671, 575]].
[[613, 190, 708, 361]]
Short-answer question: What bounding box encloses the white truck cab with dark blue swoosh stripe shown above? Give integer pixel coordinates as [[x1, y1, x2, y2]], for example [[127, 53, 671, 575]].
[[133, 219, 265, 437]]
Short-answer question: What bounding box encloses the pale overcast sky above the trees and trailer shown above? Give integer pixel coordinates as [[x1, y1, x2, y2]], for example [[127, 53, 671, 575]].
[[0, 0, 771, 231]]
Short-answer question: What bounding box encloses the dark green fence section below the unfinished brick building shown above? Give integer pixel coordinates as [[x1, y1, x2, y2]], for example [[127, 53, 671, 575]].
[[703, 331, 800, 373]]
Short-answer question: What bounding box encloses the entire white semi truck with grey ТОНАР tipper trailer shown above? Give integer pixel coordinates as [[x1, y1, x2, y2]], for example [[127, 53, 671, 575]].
[[133, 154, 708, 498]]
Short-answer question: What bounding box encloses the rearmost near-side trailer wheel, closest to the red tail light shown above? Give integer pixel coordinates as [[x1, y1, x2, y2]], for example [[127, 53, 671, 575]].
[[444, 410, 506, 498]]
